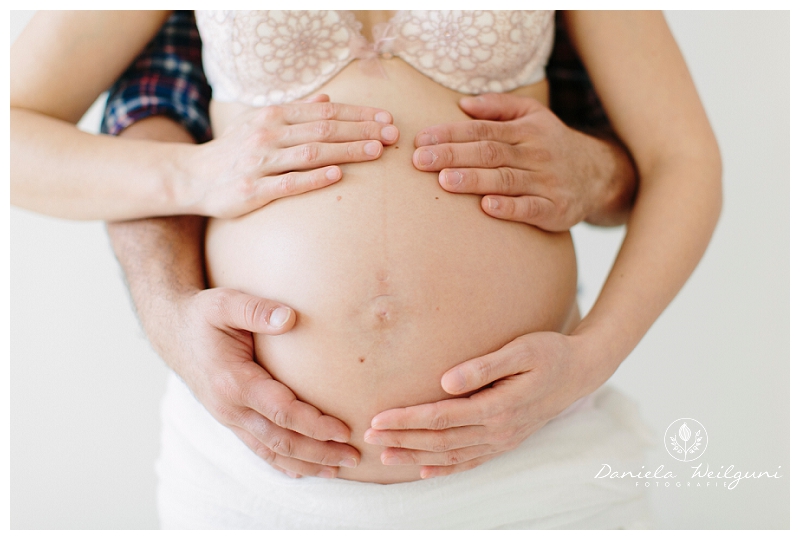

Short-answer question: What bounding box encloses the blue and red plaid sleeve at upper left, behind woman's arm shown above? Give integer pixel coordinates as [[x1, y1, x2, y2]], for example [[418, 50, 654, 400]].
[[100, 11, 211, 143]]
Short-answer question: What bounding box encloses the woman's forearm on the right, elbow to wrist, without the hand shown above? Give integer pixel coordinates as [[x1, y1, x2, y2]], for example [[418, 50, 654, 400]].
[[573, 151, 722, 390]]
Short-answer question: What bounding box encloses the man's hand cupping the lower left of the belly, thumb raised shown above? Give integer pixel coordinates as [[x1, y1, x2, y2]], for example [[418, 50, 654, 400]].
[[173, 289, 360, 478]]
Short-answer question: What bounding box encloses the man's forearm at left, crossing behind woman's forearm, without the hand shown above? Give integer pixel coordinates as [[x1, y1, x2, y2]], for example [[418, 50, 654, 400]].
[[107, 117, 206, 355]]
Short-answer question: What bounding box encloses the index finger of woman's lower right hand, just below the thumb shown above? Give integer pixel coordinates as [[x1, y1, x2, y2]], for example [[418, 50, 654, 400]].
[[371, 391, 494, 430]]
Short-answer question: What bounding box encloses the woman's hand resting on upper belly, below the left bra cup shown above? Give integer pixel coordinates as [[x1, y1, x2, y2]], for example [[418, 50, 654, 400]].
[[175, 95, 399, 218]]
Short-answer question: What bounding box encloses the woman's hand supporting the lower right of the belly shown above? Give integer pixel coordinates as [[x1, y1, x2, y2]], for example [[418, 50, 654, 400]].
[[364, 332, 610, 478]]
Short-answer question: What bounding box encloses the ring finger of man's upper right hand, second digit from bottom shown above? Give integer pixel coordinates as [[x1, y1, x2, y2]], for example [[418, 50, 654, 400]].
[[439, 167, 537, 195]]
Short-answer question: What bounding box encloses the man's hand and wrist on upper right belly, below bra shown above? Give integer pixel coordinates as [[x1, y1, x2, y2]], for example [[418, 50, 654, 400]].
[[413, 94, 636, 231]]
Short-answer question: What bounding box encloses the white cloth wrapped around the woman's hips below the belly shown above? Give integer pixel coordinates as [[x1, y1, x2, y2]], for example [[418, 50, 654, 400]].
[[156, 375, 654, 529]]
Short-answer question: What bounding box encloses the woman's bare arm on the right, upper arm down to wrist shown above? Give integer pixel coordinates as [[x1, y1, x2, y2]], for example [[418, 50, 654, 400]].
[[567, 11, 722, 372]]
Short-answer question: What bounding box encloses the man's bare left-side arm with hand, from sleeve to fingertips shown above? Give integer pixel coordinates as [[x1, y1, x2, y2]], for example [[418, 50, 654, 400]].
[[108, 117, 360, 478]]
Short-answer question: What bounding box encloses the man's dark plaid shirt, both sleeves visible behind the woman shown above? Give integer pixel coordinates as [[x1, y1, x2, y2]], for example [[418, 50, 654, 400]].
[[100, 11, 610, 139]]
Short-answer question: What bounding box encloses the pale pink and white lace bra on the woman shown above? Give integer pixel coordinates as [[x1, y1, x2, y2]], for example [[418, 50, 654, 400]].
[[196, 11, 554, 106]]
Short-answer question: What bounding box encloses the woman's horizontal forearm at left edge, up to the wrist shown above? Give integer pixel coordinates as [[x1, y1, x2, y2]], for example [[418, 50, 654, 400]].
[[11, 108, 193, 220]]
